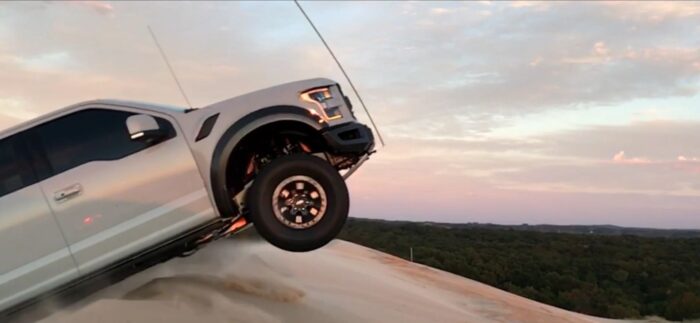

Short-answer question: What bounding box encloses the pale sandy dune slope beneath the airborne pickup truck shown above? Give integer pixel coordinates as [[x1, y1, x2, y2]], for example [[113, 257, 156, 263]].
[[34, 240, 624, 323]]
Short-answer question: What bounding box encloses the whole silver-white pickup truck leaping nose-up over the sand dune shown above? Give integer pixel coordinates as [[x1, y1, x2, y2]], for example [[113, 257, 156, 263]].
[[0, 79, 374, 318]]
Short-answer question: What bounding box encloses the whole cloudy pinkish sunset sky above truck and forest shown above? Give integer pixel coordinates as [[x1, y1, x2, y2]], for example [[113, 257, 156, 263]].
[[0, 1, 700, 229]]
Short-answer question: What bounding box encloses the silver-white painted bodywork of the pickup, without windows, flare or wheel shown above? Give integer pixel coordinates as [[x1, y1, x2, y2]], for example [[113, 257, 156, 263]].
[[0, 78, 370, 311]]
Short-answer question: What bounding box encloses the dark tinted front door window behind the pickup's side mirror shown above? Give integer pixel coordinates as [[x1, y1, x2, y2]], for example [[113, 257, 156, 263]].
[[36, 109, 175, 174]]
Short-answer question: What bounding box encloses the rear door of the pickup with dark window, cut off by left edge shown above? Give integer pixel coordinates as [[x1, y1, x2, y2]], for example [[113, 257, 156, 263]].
[[0, 134, 78, 310]]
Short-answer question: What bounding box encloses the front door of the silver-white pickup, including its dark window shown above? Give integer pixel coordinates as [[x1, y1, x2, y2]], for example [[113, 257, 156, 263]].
[[35, 107, 216, 274]]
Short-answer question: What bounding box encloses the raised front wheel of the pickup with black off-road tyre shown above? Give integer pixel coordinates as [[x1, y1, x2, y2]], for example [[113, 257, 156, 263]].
[[246, 154, 350, 251]]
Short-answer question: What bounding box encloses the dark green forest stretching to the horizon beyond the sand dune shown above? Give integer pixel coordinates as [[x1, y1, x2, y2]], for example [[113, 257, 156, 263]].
[[340, 218, 700, 320]]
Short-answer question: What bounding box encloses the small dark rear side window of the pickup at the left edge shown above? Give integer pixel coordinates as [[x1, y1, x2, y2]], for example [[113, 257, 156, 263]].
[[0, 136, 36, 197]]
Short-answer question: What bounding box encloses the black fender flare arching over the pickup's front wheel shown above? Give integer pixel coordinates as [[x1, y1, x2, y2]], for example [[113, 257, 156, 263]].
[[211, 105, 328, 217]]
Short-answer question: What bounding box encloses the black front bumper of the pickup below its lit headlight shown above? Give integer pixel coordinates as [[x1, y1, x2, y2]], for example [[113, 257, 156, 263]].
[[322, 122, 374, 155]]
